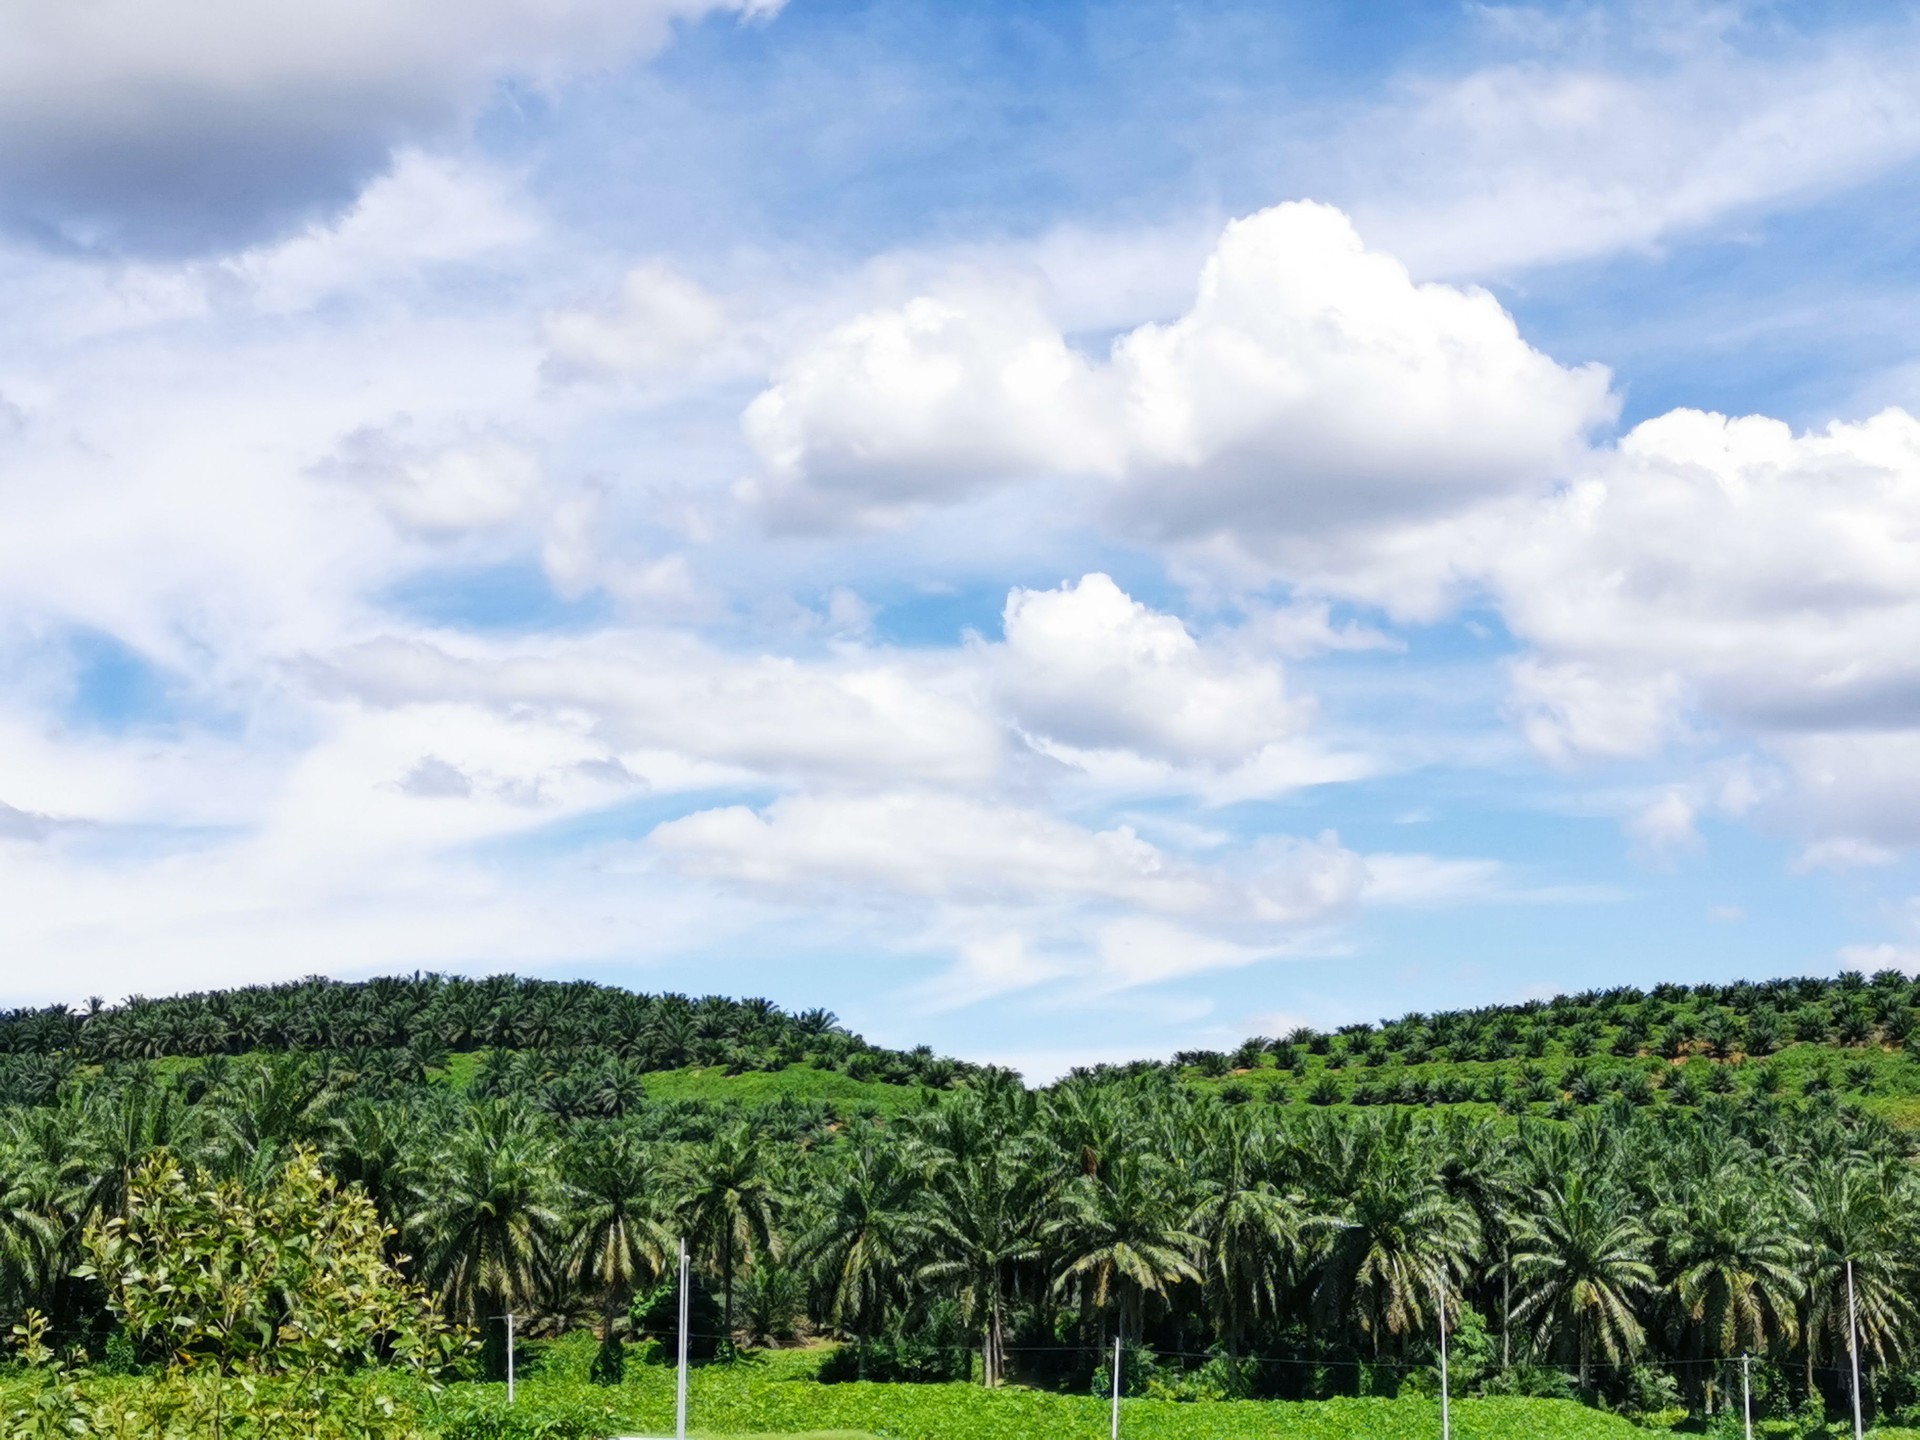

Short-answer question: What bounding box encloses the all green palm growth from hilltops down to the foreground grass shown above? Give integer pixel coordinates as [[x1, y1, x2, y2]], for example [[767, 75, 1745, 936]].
[[0, 972, 1920, 1434]]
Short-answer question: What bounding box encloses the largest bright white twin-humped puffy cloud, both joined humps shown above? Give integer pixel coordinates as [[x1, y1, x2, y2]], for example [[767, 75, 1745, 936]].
[[745, 204, 1615, 611]]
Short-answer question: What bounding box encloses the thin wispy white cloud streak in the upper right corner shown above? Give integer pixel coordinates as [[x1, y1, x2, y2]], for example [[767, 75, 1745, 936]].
[[1336, 19, 1920, 276]]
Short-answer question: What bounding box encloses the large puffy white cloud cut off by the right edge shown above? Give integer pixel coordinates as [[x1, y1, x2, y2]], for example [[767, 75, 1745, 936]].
[[1488, 411, 1920, 854]]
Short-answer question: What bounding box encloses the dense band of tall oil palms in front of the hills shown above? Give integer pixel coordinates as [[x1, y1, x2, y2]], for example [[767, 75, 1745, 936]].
[[0, 1029, 1920, 1436]]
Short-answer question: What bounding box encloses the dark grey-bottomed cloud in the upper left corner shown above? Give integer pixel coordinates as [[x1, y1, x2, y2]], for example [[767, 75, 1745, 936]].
[[0, 0, 780, 252]]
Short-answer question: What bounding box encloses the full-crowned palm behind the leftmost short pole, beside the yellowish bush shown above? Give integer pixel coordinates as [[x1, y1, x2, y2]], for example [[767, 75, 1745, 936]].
[[407, 1100, 561, 1367]]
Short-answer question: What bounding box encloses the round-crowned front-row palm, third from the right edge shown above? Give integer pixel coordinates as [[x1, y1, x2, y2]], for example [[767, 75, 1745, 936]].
[[1513, 1171, 1655, 1390]]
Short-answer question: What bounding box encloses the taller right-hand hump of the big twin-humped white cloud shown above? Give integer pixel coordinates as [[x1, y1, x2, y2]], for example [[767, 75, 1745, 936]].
[[1114, 204, 1615, 549]]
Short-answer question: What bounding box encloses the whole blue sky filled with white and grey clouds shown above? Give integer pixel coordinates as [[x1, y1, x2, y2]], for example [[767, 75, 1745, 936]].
[[0, 0, 1920, 1079]]
